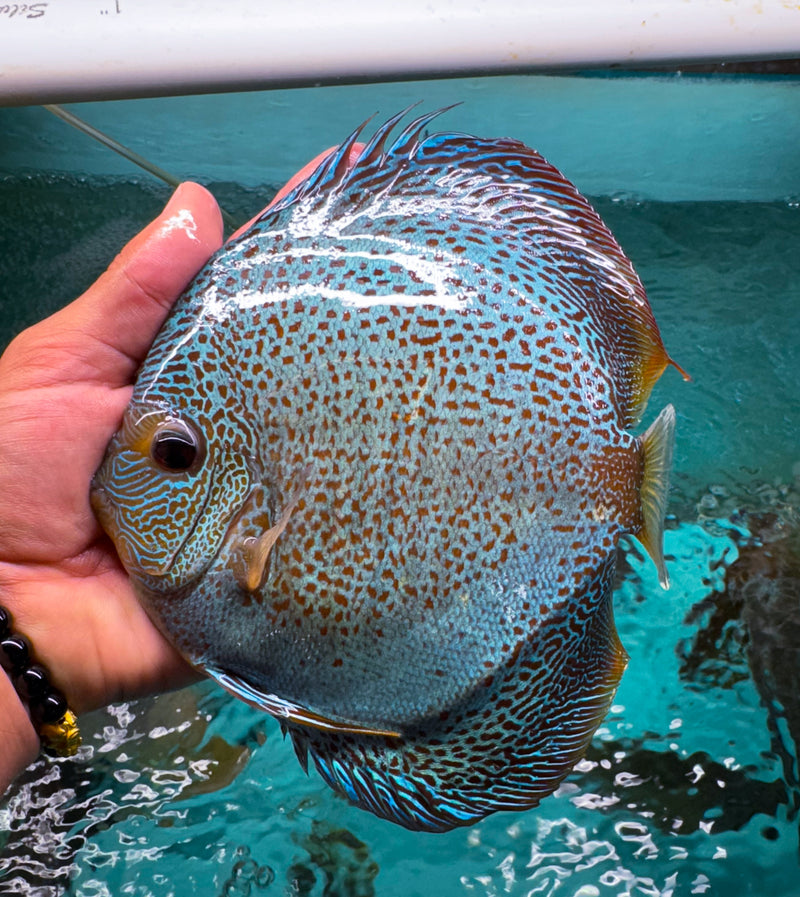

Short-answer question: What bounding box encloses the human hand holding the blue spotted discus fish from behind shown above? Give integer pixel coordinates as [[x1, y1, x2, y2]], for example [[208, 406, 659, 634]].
[[0, 147, 360, 793]]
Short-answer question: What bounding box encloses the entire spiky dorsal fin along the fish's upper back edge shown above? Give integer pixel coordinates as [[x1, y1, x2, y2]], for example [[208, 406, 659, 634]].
[[254, 107, 680, 426]]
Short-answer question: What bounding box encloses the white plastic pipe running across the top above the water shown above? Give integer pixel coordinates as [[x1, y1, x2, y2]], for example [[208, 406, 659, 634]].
[[0, 0, 800, 105]]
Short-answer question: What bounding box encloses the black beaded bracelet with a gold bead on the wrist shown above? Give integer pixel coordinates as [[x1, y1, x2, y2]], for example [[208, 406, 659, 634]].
[[0, 605, 81, 757]]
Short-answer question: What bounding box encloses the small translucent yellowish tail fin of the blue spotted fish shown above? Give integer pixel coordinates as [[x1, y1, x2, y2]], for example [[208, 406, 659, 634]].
[[637, 405, 675, 589]]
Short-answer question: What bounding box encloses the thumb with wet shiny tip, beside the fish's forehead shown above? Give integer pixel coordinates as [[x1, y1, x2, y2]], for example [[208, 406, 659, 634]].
[[45, 183, 222, 386]]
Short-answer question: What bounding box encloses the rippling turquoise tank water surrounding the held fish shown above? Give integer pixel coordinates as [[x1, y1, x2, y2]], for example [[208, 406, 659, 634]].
[[0, 177, 800, 897]]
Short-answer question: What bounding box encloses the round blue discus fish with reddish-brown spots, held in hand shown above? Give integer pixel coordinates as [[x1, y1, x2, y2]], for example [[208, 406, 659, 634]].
[[92, 113, 677, 831]]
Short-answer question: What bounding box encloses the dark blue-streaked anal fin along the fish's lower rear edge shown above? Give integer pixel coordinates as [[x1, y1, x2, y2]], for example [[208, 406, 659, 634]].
[[290, 553, 627, 832]]
